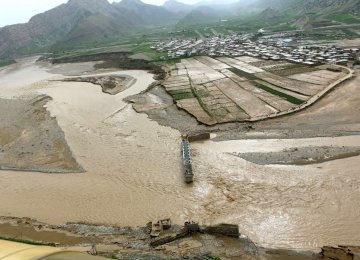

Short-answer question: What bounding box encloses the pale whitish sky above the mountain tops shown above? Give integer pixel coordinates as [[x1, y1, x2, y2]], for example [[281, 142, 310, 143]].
[[0, 0, 205, 27]]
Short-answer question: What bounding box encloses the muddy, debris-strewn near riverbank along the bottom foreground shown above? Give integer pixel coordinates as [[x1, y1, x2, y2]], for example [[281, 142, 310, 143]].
[[0, 217, 360, 260]]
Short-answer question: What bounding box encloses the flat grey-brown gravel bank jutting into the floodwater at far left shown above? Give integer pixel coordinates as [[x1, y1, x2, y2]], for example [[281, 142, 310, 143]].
[[0, 96, 83, 173]]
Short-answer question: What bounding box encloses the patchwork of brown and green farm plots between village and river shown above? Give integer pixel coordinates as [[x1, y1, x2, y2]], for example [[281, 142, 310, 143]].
[[162, 56, 346, 125]]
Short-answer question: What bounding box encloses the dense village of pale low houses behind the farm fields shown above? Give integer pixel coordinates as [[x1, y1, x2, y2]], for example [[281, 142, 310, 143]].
[[151, 34, 359, 65]]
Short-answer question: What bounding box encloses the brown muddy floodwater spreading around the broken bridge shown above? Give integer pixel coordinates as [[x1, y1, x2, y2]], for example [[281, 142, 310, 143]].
[[0, 58, 360, 249]]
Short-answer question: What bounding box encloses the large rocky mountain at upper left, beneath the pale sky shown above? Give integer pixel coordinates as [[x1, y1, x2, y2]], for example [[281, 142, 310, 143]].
[[0, 0, 176, 57]]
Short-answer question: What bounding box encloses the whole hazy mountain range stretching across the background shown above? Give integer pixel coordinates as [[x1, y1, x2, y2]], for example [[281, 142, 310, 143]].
[[0, 0, 360, 57]]
